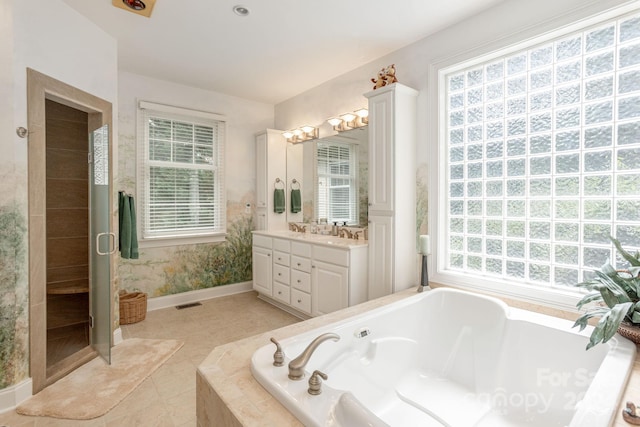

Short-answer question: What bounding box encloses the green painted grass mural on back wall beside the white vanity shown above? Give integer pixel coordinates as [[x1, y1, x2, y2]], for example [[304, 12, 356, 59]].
[[155, 216, 253, 296]]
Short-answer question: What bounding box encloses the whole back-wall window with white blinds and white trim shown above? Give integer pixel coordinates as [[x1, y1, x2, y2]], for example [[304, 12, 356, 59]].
[[138, 101, 226, 243]]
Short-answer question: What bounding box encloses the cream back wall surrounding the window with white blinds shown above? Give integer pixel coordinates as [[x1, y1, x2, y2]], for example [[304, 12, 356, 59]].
[[115, 72, 273, 297]]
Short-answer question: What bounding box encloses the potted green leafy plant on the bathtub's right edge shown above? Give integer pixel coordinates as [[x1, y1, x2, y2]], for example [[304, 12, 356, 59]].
[[573, 237, 640, 350]]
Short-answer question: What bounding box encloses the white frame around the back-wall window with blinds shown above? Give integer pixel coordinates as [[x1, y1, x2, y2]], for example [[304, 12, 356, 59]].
[[136, 100, 227, 248]]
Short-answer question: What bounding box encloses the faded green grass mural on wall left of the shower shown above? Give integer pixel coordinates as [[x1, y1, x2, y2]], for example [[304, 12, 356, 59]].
[[0, 202, 28, 389]]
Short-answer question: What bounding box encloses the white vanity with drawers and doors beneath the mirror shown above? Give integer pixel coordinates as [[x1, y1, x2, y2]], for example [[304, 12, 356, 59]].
[[253, 231, 368, 318]]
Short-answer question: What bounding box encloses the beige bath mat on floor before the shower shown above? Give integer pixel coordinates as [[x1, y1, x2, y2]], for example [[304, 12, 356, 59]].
[[16, 338, 184, 420]]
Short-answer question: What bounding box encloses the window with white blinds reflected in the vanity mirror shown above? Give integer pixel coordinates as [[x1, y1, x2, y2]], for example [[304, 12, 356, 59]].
[[316, 142, 359, 224]]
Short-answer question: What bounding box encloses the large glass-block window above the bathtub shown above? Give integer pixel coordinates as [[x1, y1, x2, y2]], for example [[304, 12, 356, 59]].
[[439, 12, 640, 302]]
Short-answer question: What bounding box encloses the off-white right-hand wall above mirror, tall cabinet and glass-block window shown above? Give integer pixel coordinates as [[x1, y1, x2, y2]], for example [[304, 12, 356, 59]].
[[275, 0, 631, 258]]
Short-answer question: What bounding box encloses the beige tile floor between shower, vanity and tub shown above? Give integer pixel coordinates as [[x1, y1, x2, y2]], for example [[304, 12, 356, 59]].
[[0, 292, 299, 427]]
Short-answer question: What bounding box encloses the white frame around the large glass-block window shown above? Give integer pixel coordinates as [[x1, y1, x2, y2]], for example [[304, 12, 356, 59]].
[[428, 4, 639, 312]]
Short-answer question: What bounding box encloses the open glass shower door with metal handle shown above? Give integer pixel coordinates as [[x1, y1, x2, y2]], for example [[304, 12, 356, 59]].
[[89, 125, 116, 364]]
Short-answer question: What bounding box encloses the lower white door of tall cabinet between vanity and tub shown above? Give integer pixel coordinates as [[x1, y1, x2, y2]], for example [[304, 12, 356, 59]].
[[368, 215, 394, 300]]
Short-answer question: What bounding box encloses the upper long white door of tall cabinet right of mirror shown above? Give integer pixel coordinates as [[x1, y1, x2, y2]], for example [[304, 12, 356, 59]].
[[369, 91, 394, 212]]
